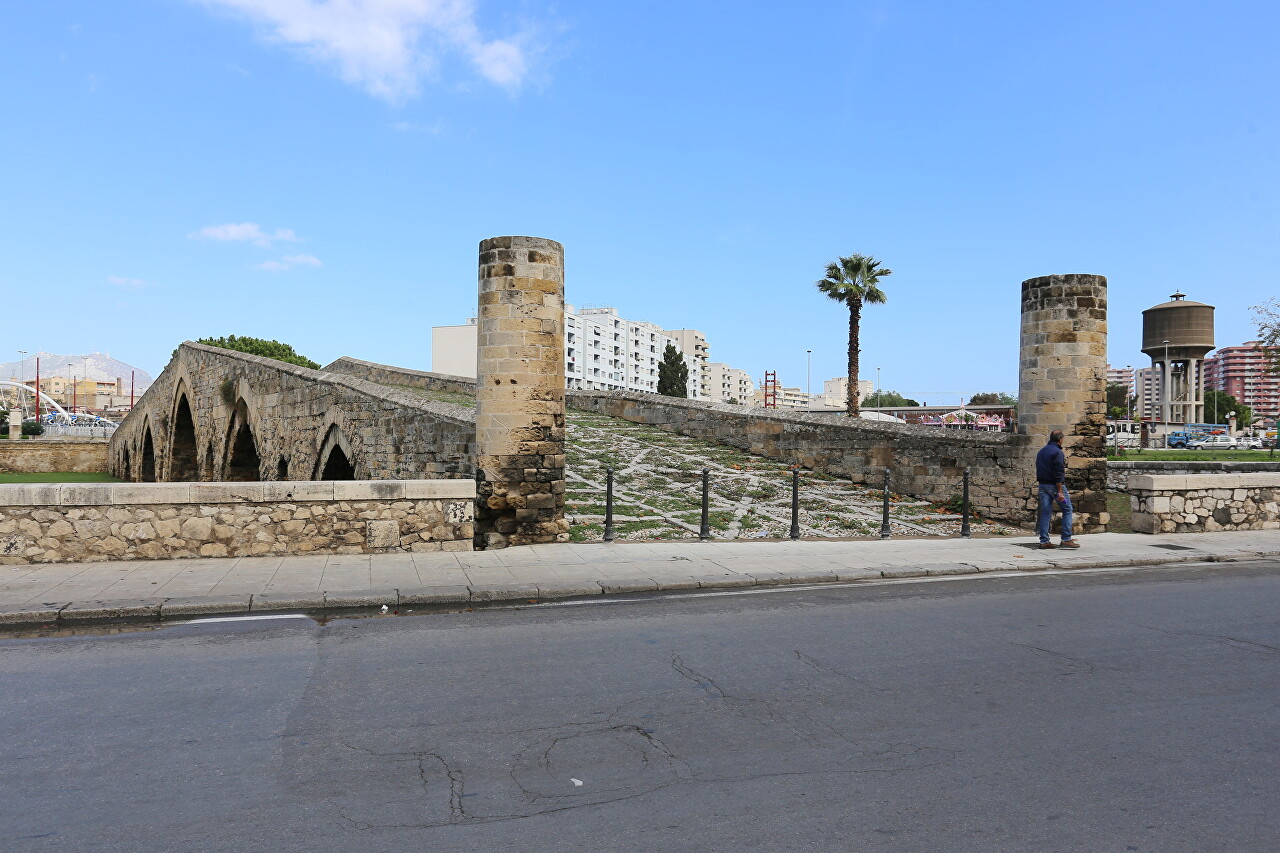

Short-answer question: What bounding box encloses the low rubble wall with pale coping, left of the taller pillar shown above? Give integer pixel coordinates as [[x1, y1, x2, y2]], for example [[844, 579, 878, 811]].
[[0, 480, 476, 565]]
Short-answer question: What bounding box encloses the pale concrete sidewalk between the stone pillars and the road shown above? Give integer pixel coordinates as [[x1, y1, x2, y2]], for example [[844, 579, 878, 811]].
[[0, 530, 1280, 626]]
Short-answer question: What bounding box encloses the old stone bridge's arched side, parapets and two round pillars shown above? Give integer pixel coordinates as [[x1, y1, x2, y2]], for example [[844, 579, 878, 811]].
[[110, 237, 1107, 547]]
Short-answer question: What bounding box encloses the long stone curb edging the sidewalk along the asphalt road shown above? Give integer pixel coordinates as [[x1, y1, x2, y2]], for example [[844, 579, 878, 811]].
[[0, 551, 1280, 630]]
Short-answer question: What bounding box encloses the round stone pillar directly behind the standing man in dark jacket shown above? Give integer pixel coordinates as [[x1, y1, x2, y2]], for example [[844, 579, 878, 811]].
[[1018, 274, 1107, 533]]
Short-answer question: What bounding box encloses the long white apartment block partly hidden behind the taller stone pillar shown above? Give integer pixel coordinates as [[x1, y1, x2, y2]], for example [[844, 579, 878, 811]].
[[431, 305, 708, 400]]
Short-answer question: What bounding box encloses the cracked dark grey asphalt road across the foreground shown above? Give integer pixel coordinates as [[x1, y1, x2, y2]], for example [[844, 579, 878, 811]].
[[0, 564, 1280, 853]]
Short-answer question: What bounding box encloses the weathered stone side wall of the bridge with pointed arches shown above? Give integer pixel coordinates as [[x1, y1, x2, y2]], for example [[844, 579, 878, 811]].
[[110, 342, 475, 482]]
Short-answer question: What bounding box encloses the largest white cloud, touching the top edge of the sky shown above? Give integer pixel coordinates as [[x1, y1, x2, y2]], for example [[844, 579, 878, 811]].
[[204, 0, 529, 102]]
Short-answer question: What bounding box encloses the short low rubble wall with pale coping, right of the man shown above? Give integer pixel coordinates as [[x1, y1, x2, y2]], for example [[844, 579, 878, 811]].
[[1129, 473, 1280, 533]]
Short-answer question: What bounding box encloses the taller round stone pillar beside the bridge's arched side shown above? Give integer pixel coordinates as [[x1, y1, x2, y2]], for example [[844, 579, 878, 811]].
[[476, 237, 568, 548]]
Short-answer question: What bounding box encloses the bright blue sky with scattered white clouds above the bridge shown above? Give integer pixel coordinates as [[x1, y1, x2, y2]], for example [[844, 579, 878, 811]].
[[0, 0, 1280, 402]]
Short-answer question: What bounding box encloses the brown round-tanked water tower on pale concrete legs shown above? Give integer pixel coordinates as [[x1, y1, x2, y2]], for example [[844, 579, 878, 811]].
[[1142, 293, 1213, 424]]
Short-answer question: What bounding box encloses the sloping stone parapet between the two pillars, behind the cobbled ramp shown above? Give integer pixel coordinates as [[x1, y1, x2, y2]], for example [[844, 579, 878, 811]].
[[567, 391, 1044, 524]]
